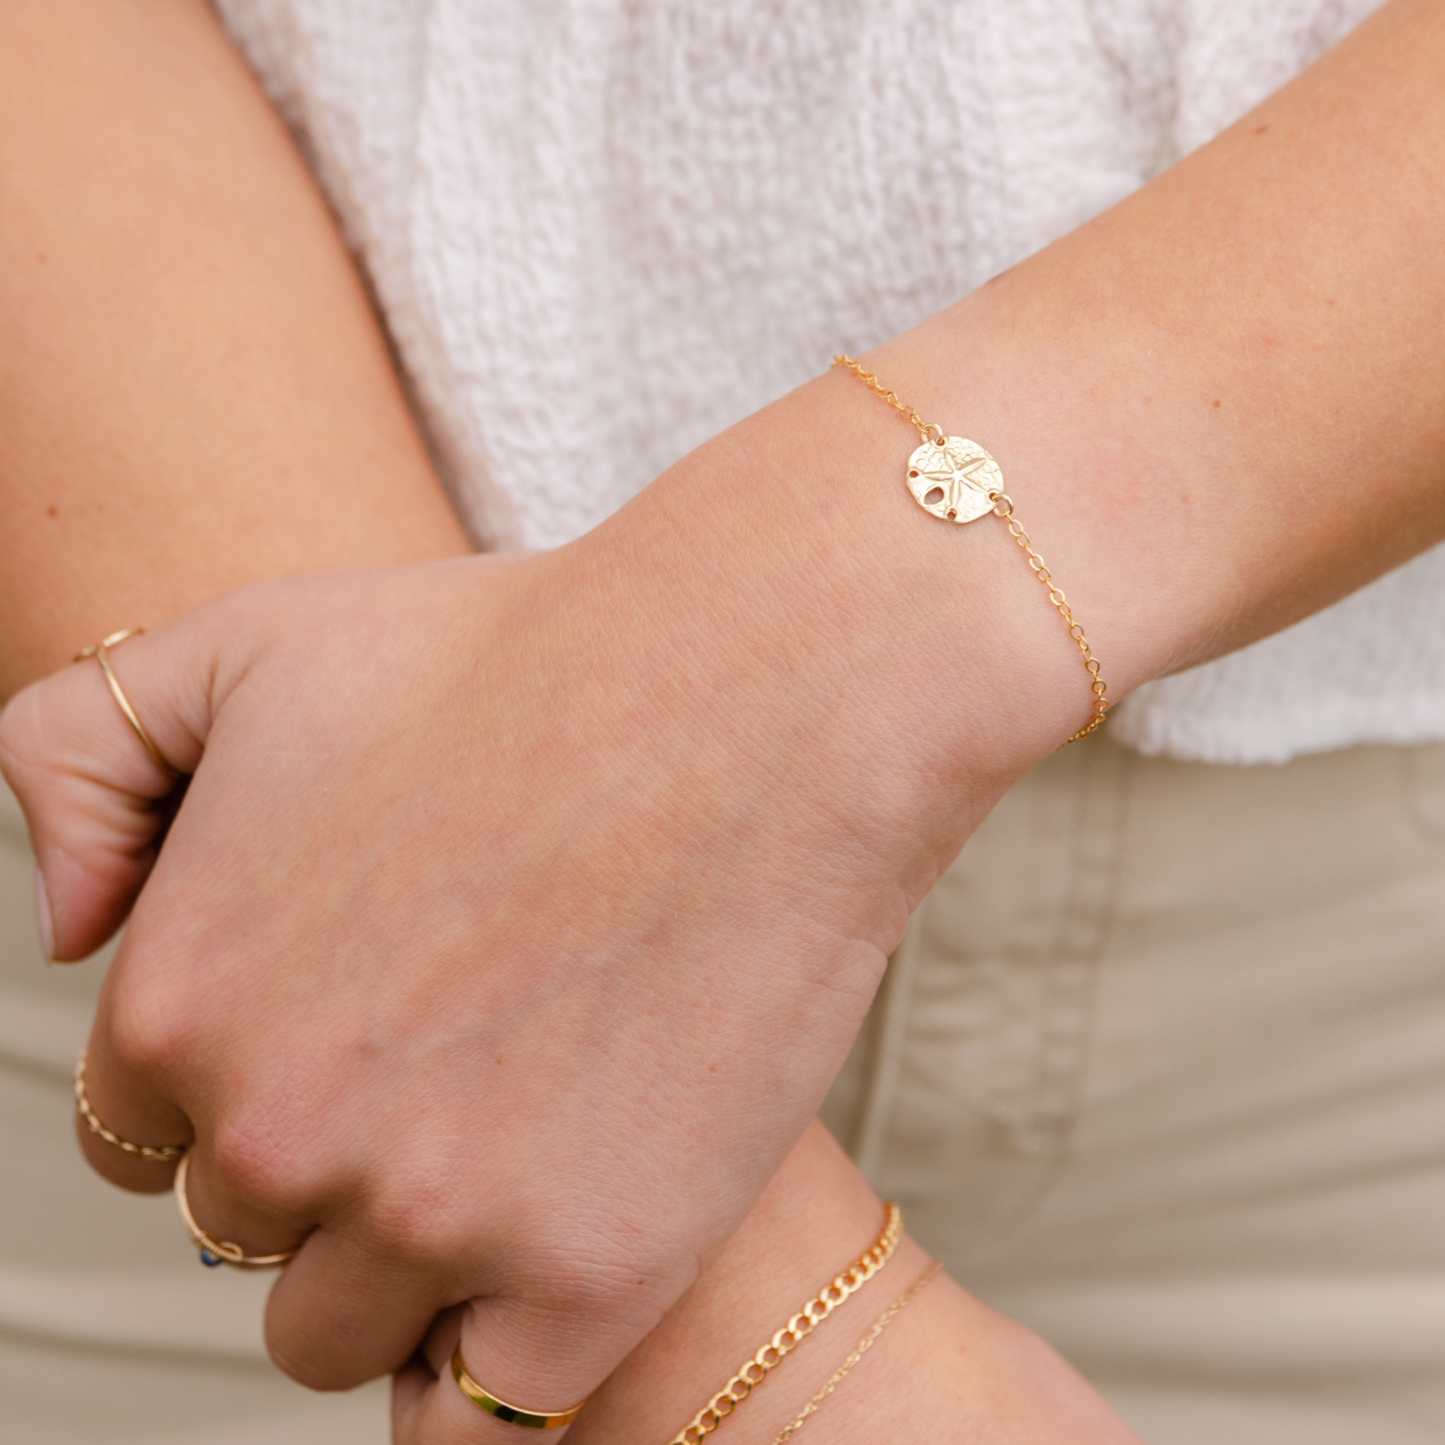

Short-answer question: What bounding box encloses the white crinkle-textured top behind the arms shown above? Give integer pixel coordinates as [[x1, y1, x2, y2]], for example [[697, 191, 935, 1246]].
[[209, 0, 1445, 762]]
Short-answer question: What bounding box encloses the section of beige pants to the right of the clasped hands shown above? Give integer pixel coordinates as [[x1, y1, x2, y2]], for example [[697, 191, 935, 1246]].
[[828, 740, 1445, 1445]]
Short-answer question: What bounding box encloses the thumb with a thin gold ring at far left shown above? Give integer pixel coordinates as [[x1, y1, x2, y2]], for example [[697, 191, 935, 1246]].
[[0, 614, 225, 961]]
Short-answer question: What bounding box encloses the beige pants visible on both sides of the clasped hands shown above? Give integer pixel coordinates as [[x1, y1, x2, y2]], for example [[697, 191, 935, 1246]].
[[0, 738, 1445, 1445]]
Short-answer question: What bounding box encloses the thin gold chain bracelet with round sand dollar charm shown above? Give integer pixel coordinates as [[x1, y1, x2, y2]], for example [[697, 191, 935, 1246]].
[[832, 355, 1110, 743]]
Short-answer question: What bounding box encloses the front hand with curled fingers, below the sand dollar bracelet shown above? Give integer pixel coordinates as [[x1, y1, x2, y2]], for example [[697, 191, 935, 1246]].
[[0, 476, 1088, 1439]]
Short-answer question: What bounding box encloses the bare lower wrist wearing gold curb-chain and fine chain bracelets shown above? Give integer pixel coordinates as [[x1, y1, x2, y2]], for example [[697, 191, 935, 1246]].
[[407, 1121, 1139, 1445]]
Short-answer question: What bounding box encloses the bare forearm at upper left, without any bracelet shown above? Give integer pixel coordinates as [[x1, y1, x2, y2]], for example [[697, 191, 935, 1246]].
[[0, 0, 465, 699]]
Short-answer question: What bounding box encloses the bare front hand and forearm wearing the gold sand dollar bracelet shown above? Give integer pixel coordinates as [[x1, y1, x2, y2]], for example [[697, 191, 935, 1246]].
[[0, 0, 1445, 1441]]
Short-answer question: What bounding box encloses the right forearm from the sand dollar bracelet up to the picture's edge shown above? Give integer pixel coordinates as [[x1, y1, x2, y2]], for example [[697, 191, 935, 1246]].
[[855, 0, 1445, 688]]
